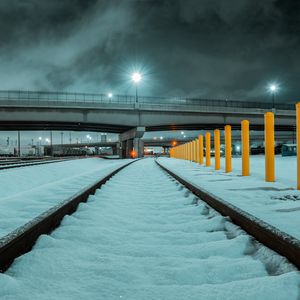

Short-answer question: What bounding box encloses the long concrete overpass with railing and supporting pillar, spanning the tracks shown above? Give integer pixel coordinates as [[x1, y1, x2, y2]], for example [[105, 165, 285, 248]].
[[0, 91, 295, 156]]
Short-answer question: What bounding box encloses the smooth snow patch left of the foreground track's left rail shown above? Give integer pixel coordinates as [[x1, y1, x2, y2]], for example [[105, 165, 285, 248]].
[[0, 158, 128, 237]]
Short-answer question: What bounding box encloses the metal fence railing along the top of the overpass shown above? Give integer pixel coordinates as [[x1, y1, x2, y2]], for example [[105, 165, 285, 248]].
[[0, 90, 295, 110]]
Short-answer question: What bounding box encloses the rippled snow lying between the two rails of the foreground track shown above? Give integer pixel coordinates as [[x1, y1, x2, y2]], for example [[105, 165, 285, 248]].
[[0, 159, 300, 300]]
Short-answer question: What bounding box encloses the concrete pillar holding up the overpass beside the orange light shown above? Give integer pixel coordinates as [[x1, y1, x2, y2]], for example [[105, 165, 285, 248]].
[[119, 127, 145, 158]]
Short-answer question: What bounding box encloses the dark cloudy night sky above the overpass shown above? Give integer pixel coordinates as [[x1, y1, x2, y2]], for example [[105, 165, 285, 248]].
[[0, 0, 300, 102]]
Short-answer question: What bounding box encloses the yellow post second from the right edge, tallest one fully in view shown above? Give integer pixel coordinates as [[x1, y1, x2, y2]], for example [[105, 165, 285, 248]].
[[265, 112, 275, 182]]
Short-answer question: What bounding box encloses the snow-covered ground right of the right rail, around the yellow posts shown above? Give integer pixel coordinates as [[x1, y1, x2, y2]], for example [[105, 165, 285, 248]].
[[159, 155, 300, 239]]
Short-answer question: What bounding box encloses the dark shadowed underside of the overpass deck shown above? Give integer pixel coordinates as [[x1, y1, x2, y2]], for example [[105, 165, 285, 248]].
[[0, 121, 295, 133]]
